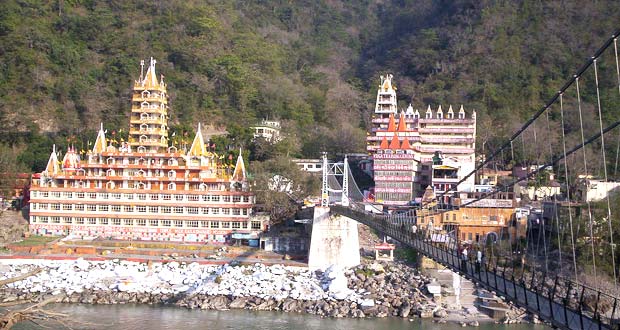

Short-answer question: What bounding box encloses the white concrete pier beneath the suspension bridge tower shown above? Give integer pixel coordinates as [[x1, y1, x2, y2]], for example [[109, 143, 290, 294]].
[[308, 206, 361, 270]]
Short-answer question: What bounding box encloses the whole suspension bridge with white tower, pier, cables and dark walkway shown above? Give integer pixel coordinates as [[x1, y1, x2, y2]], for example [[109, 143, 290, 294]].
[[309, 30, 620, 329]]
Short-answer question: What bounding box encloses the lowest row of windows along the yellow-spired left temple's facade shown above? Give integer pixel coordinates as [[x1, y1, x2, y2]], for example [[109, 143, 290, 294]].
[[31, 216, 262, 230]]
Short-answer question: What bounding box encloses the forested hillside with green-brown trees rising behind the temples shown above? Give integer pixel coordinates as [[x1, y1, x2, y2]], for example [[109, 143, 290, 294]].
[[0, 0, 620, 170]]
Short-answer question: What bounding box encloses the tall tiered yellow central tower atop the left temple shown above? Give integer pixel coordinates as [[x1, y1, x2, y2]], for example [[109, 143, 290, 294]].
[[129, 57, 168, 152]]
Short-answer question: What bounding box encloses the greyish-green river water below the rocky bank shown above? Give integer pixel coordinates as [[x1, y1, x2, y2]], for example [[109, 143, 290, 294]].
[[14, 304, 549, 330]]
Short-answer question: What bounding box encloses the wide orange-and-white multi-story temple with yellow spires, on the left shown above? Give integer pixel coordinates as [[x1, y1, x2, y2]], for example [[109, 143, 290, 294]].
[[30, 59, 267, 242]]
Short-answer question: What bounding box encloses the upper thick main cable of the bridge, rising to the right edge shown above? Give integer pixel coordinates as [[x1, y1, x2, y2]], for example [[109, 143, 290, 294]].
[[441, 29, 620, 199]]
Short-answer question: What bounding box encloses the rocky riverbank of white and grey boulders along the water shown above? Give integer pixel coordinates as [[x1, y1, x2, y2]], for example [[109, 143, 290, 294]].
[[0, 259, 528, 319]]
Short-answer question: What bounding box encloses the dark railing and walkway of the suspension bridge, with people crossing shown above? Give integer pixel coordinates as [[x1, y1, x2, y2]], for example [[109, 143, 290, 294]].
[[331, 205, 620, 330]]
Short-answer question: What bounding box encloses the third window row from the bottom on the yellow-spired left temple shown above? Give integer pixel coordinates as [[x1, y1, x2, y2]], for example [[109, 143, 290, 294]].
[[32, 191, 252, 203]]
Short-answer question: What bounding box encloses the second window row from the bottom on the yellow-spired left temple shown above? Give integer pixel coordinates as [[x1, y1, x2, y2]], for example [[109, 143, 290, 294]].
[[30, 203, 250, 215]]
